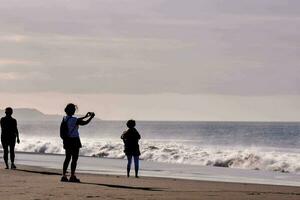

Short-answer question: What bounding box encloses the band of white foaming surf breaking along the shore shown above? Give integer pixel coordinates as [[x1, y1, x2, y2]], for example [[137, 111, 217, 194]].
[[10, 137, 300, 174]]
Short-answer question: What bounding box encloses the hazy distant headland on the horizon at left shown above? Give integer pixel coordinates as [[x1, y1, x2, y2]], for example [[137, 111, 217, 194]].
[[0, 108, 100, 121]]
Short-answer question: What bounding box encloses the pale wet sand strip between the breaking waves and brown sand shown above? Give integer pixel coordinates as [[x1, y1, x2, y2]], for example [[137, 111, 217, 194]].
[[0, 153, 300, 187]]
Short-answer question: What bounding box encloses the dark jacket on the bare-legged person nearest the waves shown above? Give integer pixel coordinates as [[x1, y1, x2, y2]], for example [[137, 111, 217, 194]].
[[121, 128, 141, 156]]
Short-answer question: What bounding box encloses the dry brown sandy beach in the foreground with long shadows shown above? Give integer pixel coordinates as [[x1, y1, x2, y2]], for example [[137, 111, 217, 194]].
[[0, 166, 300, 200]]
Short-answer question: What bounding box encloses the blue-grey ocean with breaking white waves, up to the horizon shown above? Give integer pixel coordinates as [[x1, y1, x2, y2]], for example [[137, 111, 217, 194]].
[[16, 121, 300, 175]]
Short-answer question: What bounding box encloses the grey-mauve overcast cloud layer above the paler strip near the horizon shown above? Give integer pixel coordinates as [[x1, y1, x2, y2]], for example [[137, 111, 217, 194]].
[[0, 0, 300, 95]]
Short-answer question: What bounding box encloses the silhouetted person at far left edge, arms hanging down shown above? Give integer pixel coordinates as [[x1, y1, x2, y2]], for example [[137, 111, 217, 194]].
[[1, 107, 20, 169]]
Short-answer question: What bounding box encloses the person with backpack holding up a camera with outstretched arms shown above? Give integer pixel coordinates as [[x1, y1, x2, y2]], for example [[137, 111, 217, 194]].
[[61, 103, 95, 182]]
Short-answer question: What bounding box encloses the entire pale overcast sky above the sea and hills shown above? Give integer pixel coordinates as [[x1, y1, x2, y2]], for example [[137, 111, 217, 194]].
[[0, 0, 300, 121]]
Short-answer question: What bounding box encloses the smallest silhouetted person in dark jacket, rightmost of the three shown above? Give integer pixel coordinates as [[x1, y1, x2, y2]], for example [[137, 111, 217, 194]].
[[121, 119, 141, 178]]
